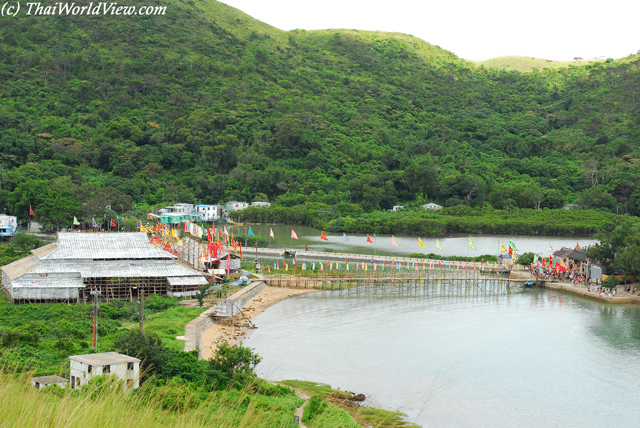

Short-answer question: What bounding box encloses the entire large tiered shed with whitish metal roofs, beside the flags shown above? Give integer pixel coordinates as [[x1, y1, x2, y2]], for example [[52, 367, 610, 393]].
[[2, 232, 208, 302]]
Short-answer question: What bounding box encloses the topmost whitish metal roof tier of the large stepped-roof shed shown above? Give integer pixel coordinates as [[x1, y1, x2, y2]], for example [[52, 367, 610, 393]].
[[38, 232, 175, 260]]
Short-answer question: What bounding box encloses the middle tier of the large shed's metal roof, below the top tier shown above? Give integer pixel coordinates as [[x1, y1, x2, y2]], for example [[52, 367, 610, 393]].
[[31, 260, 202, 278]]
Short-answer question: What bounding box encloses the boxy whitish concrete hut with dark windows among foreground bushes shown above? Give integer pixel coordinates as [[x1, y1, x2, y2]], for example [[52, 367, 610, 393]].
[[69, 352, 140, 392]]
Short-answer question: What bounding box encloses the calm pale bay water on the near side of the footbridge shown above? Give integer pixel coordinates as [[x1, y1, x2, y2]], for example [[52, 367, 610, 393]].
[[244, 288, 640, 427]]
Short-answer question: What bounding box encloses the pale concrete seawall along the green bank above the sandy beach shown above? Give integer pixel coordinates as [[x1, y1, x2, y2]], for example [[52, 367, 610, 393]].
[[184, 275, 267, 359]]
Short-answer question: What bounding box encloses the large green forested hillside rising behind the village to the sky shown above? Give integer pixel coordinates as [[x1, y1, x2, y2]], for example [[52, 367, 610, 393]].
[[0, 0, 640, 229]]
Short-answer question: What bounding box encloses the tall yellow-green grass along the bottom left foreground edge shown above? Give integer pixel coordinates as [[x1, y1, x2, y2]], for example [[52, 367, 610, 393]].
[[0, 375, 301, 428]]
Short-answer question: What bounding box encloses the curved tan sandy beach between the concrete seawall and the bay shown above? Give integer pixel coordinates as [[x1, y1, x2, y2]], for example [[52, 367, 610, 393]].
[[202, 287, 320, 359]]
